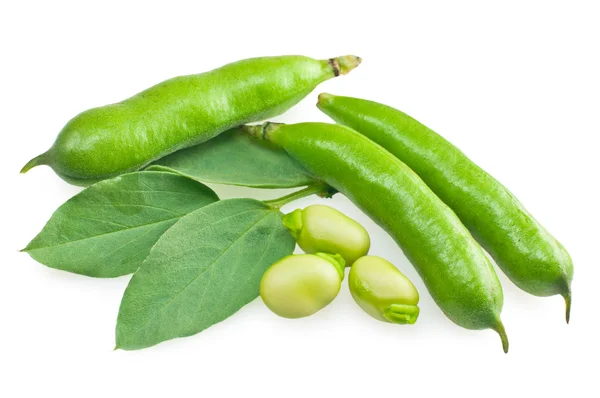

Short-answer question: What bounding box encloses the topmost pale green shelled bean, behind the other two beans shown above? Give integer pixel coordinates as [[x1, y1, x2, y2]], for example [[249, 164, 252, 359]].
[[283, 205, 371, 267]]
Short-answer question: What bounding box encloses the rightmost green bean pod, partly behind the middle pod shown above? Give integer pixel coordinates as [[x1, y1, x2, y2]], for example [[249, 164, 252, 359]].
[[318, 94, 573, 322]]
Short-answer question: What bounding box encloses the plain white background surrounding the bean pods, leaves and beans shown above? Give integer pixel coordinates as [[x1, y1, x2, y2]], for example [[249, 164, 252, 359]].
[[0, 0, 600, 397]]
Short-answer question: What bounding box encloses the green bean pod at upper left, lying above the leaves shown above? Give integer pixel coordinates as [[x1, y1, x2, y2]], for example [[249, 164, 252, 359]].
[[21, 56, 360, 185]]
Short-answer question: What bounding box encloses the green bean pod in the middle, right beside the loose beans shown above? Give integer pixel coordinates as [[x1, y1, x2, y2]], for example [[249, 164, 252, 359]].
[[246, 123, 508, 352]]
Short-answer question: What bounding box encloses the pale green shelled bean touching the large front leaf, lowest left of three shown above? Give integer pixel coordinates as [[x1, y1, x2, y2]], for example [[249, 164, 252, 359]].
[[260, 253, 344, 318]]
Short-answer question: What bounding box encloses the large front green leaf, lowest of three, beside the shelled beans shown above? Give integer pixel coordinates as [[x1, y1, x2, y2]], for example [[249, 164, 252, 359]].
[[116, 199, 295, 350]]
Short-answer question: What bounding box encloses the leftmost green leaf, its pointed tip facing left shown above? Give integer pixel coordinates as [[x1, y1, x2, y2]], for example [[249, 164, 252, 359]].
[[23, 171, 219, 278]]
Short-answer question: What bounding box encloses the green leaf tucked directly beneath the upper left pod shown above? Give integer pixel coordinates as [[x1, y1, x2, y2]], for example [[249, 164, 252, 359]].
[[147, 129, 315, 188]]
